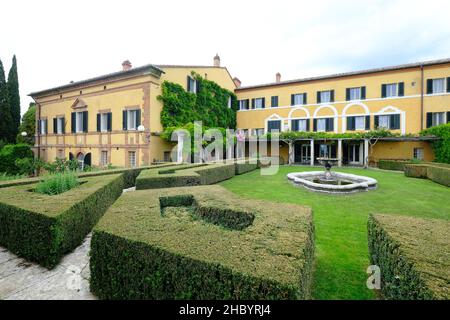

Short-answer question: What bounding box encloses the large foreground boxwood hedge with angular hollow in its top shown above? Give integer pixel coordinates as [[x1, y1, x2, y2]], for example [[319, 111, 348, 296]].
[[90, 185, 314, 299]]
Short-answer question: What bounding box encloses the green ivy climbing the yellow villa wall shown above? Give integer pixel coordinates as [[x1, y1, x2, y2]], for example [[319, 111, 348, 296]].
[[158, 72, 238, 129]]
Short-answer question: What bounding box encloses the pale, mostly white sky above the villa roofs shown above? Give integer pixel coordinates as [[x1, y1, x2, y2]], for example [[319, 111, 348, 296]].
[[0, 0, 450, 113]]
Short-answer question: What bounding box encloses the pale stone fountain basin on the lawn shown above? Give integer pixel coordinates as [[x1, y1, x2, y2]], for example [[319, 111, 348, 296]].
[[287, 171, 378, 194]]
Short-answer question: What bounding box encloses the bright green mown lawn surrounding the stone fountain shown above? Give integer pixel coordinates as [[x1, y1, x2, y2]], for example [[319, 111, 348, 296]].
[[221, 166, 450, 299]]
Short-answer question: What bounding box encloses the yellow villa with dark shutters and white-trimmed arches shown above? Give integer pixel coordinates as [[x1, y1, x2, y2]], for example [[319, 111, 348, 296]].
[[31, 56, 450, 166]]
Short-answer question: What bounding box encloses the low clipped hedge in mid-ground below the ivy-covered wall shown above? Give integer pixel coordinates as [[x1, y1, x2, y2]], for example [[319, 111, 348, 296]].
[[136, 163, 236, 190]]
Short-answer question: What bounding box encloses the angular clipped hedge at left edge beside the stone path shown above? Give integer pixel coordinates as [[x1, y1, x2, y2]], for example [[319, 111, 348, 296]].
[[0, 174, 124, 268]]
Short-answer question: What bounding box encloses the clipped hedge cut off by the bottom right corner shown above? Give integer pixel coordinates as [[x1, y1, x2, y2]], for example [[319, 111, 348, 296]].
[[368, 214, 450, 300]]
